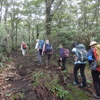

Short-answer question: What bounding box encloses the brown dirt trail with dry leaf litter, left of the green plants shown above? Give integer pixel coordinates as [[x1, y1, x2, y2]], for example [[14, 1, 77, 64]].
[[0, 51, 96, 100]]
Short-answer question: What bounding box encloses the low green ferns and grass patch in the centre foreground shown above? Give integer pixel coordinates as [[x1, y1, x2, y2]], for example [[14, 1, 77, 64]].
[[31, 69, 88, 100]]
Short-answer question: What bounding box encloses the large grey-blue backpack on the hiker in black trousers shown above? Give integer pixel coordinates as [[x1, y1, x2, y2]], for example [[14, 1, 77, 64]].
[[76, 44, 88, 62]]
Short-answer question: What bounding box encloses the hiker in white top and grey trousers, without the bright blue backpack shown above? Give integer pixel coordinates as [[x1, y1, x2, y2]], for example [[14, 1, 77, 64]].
[[35, 39, 42, 65]]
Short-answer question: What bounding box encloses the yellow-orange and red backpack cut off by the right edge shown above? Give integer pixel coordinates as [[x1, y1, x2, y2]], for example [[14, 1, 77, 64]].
[[93, 44, 100, 71]]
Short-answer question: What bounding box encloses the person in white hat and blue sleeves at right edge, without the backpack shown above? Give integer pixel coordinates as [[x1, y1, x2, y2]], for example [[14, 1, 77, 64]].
[[88, 41, 100, 99]]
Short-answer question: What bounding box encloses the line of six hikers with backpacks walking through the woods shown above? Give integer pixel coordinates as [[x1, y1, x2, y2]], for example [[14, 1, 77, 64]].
[[21, 39, 100, 99]]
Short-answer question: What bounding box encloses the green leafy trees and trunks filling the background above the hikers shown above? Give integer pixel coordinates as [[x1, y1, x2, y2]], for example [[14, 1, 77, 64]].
[[0, 0, 100, 50]]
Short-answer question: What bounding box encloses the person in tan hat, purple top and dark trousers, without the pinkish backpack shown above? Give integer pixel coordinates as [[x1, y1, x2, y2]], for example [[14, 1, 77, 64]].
[[57, 45, 69, 70]]
